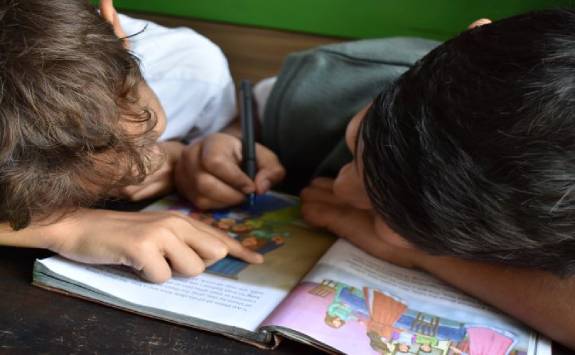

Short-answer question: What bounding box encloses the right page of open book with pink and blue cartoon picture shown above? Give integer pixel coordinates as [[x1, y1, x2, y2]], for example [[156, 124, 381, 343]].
[[258, 240, 550, 355]]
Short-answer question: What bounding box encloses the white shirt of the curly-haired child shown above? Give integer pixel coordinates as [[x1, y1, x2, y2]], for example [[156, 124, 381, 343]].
[[119, 15, 236, 140]]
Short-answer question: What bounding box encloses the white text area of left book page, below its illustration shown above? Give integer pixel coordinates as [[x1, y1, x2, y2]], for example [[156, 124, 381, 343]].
[[39, 257, 287, 331]]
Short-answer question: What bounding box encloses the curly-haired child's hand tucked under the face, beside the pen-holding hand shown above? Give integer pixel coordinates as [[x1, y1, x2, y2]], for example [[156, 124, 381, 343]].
[[118, 142, 184, 201]]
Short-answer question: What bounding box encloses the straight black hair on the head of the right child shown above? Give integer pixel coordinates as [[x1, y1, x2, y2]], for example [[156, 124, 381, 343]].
[[361, 10, 575, 275]]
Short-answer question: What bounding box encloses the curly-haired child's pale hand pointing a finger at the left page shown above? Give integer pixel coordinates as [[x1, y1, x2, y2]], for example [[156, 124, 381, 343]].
[[47, 210, 263, 283]]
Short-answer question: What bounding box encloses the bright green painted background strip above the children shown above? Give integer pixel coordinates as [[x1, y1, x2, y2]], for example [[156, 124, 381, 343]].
[[106, 0, 574, 39]]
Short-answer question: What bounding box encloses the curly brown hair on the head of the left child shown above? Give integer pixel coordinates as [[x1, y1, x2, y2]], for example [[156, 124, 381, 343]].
[[0, 0, 157, 229]]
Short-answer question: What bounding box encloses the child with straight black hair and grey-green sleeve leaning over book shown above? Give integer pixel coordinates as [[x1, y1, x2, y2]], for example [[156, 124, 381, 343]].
[[183, 10, 575, 348]]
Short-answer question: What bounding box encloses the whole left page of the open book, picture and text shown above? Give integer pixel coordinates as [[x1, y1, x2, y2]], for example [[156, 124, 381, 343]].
[[38, 194, 334, 331]]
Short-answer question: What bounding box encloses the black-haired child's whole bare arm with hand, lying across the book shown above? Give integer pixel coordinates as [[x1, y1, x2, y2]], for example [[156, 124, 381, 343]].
[[301, 179, 575, 349]]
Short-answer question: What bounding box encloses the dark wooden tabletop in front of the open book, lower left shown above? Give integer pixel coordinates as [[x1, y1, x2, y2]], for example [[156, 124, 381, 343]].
[[0, 247, 321, 355]]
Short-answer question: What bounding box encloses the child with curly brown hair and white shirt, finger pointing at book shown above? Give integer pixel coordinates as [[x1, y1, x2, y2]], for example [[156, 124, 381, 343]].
[[0, 0, 262, 282]]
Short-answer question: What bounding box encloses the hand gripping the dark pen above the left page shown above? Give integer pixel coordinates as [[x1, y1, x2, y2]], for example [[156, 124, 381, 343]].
[[175, 133, 285, 209]]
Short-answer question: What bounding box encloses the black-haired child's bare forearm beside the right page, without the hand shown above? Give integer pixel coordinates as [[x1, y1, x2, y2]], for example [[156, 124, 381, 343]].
[[420, 256, 575, 349]]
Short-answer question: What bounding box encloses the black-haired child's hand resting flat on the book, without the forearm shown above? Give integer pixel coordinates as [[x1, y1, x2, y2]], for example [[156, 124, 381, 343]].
[[301, 178, 426, 268]]
